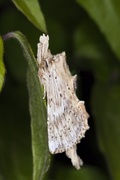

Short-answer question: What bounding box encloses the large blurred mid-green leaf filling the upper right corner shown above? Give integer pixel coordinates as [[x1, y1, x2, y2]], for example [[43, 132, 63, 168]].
[[77, 0, 120, 58]]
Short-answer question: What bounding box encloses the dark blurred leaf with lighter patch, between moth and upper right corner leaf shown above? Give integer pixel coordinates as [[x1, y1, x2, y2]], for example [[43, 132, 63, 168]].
[[74, 18, 117, 81]]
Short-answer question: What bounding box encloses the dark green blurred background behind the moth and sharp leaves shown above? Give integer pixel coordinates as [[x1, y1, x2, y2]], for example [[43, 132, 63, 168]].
[[0, 0, 120, 180]]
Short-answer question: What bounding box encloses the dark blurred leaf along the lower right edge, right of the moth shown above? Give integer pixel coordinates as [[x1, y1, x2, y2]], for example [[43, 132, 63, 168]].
[[92, 82, 120, 180]]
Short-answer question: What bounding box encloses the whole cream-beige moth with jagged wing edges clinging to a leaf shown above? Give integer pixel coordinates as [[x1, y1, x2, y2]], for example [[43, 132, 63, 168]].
[[37, 34, 89, 169]]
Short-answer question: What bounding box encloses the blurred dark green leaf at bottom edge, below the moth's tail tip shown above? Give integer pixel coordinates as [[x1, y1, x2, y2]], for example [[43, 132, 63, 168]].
[[56, 166, 108, 180]]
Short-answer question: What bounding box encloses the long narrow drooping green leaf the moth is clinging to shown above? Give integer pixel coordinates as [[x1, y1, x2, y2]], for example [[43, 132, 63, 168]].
[[4, 32, 50, 180]]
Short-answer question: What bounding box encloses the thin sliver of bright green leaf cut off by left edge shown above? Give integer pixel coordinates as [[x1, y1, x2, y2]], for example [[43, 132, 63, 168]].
[[0, 36, 5, 91]]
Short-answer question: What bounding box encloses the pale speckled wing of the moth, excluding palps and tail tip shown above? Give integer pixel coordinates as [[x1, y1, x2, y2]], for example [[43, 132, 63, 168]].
[[46, 54, 88, 153]]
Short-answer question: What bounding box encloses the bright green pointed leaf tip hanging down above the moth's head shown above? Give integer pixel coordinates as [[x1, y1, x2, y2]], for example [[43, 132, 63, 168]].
[[12, 0, 47, 32]]
